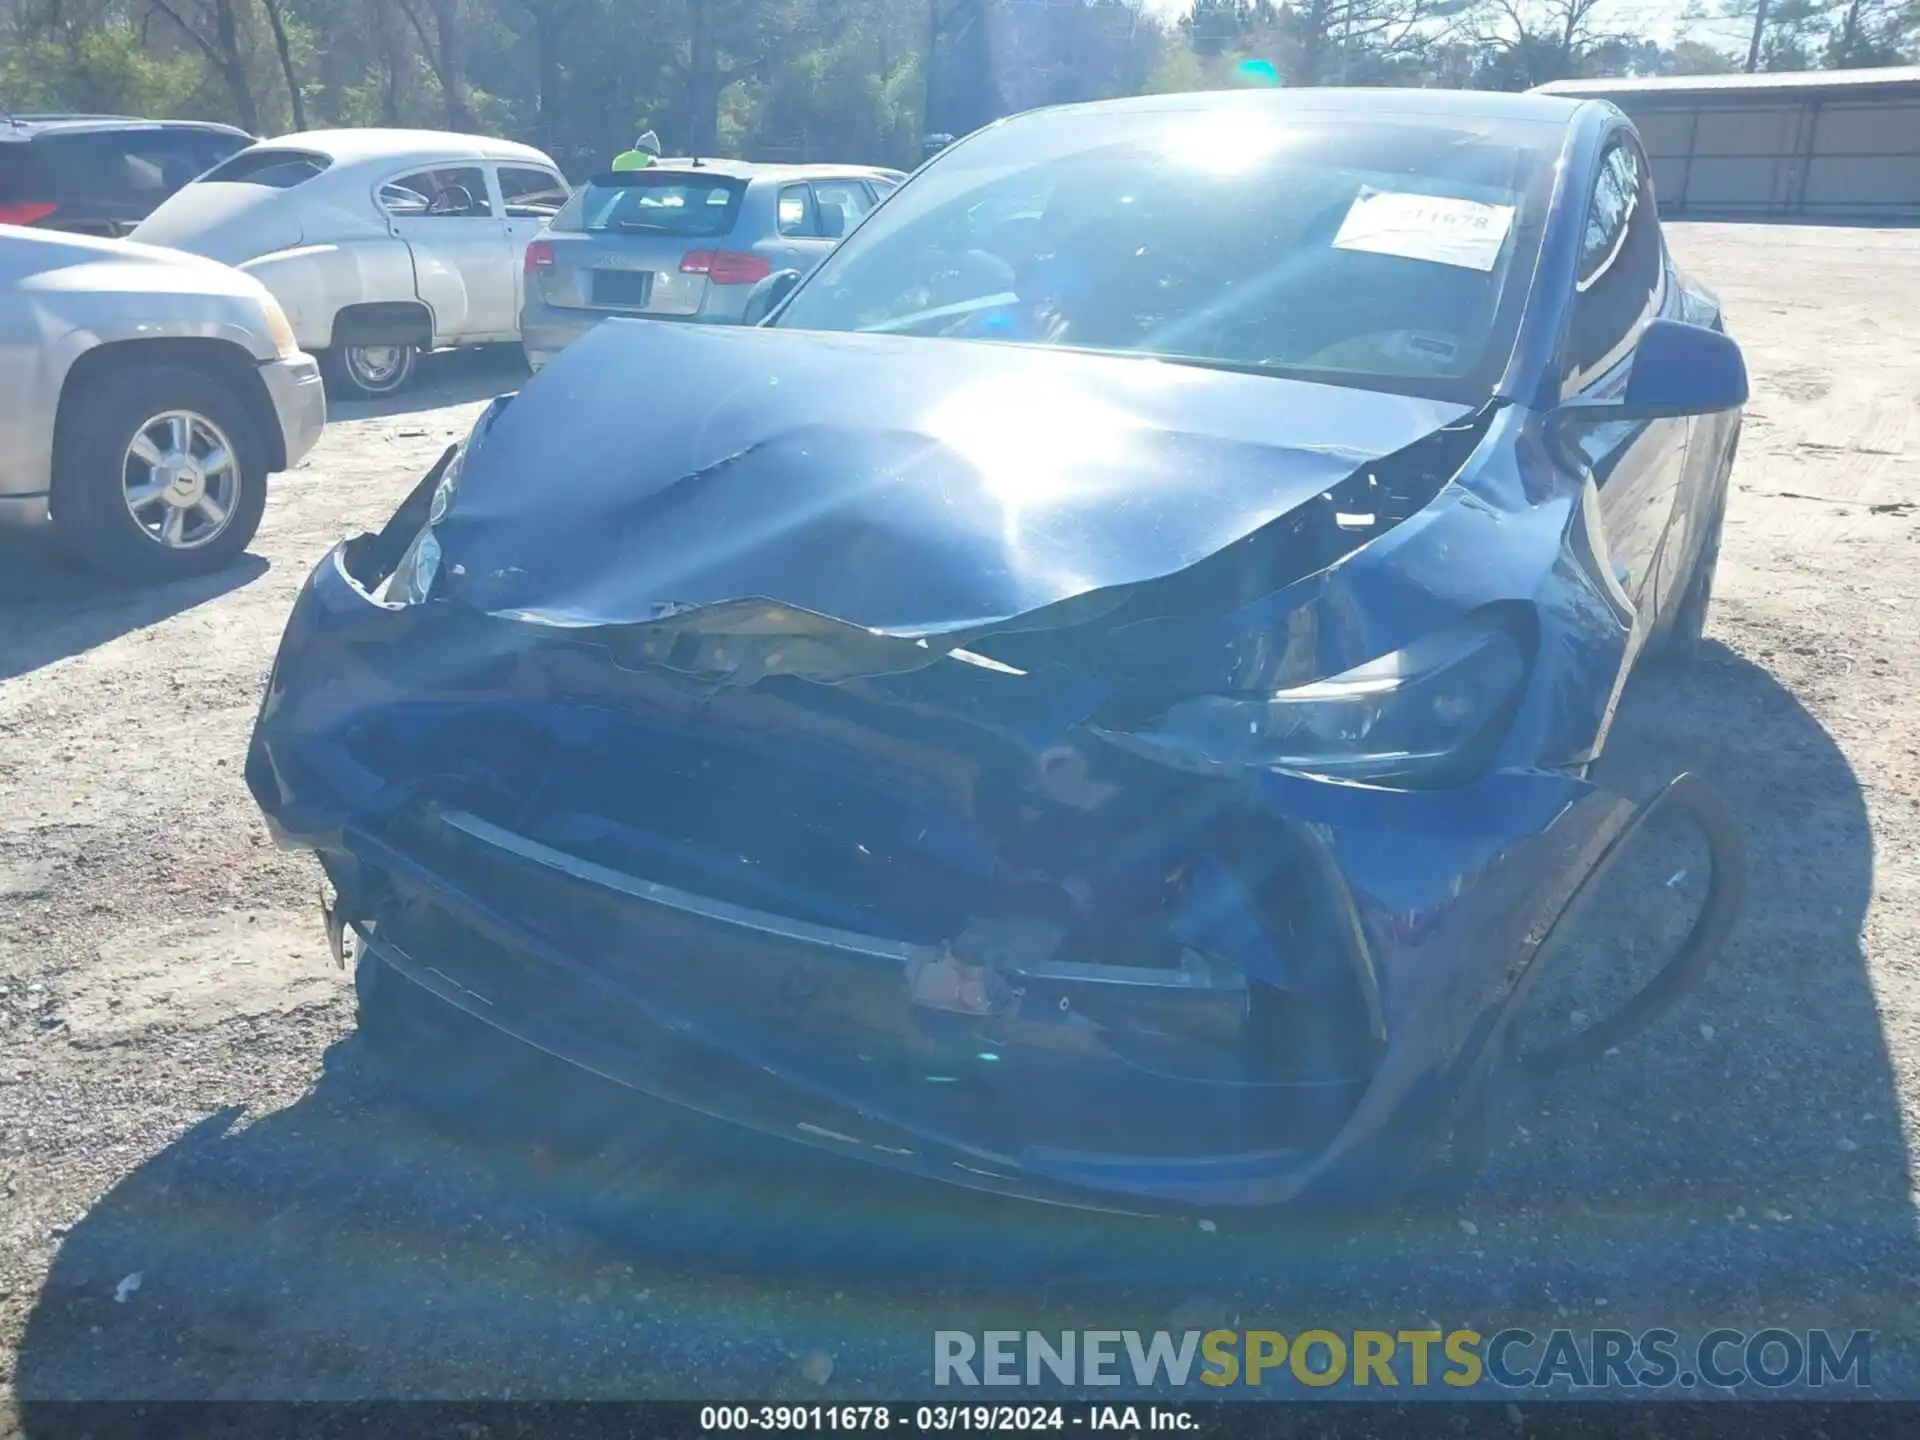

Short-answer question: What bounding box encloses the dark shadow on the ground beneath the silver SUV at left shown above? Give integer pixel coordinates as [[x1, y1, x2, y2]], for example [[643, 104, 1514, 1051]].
[[0, 536, 267, 682]]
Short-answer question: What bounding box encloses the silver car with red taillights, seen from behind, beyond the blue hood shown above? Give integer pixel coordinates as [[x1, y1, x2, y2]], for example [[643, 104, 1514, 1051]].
[[520, 159, 902, 371]]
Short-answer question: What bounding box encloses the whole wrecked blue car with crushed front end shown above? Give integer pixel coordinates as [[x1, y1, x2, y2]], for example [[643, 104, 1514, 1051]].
[[248, 90, 1747, 1206]]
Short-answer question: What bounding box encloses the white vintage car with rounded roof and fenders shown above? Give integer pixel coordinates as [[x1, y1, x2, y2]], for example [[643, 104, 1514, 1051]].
[[132, 131, 568, 396]]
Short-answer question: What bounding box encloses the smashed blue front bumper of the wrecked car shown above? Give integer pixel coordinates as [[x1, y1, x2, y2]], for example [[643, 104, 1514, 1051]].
[[248, 551, 1724, 1206]]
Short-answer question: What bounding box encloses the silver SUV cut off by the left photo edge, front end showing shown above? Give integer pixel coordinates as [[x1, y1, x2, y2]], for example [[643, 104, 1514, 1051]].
[[0, 225, 326, 582]]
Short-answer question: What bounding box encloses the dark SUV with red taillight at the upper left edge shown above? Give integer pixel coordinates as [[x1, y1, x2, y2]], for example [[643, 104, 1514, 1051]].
[[0, 111, 253, 236]]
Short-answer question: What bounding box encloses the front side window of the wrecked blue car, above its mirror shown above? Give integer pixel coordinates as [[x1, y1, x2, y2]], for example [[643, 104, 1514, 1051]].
[[1561, 138, 1667, 396]]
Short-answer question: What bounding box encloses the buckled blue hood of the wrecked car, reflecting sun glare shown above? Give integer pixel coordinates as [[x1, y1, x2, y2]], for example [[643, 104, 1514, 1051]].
[[440, 321, 1469, 636]]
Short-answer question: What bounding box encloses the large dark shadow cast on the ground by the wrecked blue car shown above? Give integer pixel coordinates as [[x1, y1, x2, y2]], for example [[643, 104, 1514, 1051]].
[[13, 647, 1920, 1413]]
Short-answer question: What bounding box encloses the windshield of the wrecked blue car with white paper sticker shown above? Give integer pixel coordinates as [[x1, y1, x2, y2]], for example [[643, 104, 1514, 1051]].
[[778, 108, 1557, 403]]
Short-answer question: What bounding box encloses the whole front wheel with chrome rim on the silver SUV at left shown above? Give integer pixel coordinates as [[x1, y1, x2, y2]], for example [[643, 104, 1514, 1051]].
[[54, 365, 267, 584]]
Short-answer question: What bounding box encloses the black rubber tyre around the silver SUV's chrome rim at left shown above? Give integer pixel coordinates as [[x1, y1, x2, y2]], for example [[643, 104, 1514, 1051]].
[[52, 365, 267, 584]]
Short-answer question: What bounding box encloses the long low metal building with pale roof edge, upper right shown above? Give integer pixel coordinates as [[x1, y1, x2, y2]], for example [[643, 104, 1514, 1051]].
[[1540, 65, 1920, 221]]
